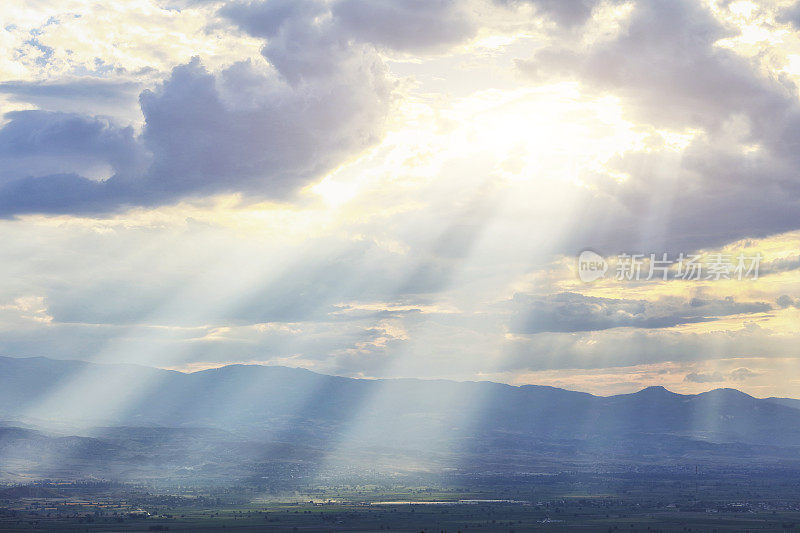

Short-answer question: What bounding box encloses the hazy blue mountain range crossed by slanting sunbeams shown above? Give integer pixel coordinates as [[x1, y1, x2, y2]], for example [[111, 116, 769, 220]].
[[0, 357, 800, 484]]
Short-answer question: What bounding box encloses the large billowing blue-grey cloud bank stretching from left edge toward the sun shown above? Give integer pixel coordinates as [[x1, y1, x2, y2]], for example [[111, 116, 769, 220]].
[[0, 10, 394, 216]]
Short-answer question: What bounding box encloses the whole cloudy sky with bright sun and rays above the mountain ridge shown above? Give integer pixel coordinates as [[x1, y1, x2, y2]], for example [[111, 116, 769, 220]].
[[0, 0, 800, 397]]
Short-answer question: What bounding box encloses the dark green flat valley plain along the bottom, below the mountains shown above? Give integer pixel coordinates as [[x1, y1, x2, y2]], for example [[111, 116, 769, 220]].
[[0, 478, 800, 533]]
